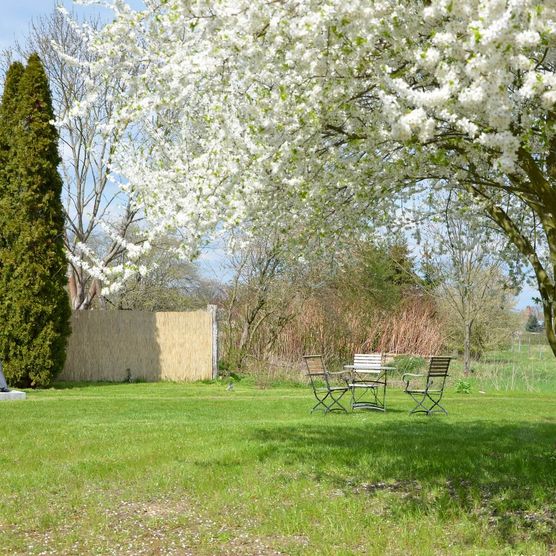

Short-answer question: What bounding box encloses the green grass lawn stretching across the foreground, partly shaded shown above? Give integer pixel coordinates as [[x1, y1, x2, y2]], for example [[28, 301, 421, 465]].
[[0, 381, 556, 555]]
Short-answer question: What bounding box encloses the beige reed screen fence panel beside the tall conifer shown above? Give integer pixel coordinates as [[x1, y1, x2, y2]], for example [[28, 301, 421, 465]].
[[59, 310, 215, 382]]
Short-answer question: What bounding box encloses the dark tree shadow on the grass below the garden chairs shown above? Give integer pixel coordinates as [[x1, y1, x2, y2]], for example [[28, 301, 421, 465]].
[[251, 417, 556, 545]]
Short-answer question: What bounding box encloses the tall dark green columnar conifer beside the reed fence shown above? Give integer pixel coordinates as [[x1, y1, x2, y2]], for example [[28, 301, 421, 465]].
[[0, 54, 70, 386]]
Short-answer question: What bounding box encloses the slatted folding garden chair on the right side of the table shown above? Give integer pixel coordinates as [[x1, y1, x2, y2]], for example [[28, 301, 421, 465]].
[[402, 356, 451, 415]]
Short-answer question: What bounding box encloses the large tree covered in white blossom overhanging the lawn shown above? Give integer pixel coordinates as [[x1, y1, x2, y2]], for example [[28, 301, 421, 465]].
[[68, 0, 556, 353]]
